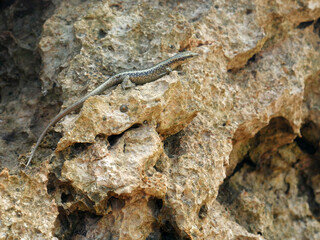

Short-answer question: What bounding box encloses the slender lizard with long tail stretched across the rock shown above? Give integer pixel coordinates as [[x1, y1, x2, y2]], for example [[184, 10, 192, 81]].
[[26, 51, 199, 167]]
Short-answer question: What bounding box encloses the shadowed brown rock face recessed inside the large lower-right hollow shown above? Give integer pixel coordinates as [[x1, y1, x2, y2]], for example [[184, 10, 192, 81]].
[[218, 139, 320, 239]]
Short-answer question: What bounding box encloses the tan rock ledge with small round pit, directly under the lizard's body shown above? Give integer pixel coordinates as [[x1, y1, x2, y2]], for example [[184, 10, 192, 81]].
[[57, 74, 197, 151]]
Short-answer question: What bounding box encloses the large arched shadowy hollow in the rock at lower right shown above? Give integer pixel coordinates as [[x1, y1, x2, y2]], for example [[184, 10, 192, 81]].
[[217, 117, 320, 236]]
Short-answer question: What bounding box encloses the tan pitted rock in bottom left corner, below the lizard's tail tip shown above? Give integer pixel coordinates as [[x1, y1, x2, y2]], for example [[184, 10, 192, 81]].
[[0, 166, 58, 239]]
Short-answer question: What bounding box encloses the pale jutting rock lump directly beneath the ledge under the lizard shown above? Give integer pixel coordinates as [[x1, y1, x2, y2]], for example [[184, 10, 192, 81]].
[[61, 126, 167, 210]]
